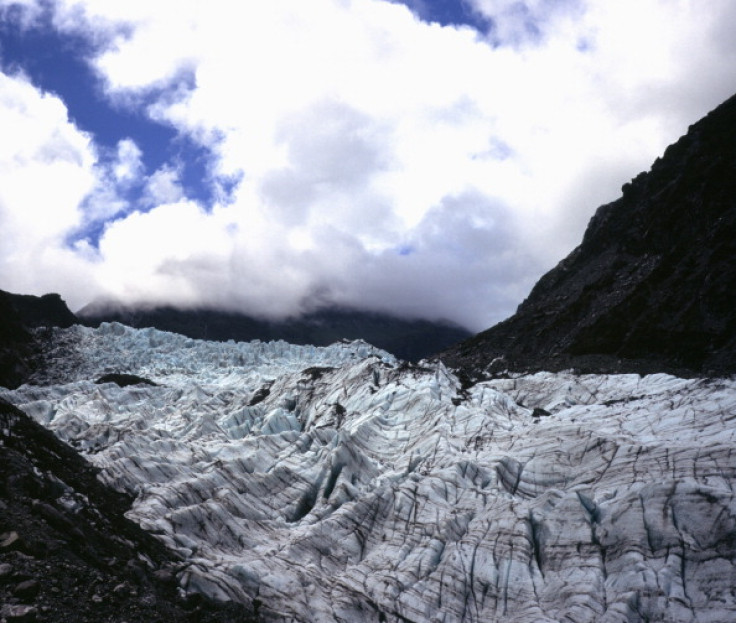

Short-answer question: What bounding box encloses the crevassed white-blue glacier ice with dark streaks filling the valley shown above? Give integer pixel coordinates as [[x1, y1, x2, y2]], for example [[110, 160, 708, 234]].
[[0, 323, 736, 623]]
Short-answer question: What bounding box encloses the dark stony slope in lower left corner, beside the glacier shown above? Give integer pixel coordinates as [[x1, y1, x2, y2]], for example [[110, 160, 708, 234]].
[[0, 401, 254, 623]]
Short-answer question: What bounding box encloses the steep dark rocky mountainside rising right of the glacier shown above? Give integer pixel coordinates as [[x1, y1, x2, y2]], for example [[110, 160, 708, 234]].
[[441, 97, 736, 379]]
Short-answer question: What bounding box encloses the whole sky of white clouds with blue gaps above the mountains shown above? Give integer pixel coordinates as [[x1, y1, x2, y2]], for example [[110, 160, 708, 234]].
[[0, 0, 736, 329]]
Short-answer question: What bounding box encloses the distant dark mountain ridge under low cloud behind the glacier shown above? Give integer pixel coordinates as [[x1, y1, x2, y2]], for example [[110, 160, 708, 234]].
[[78, 303, 471, 361]]
